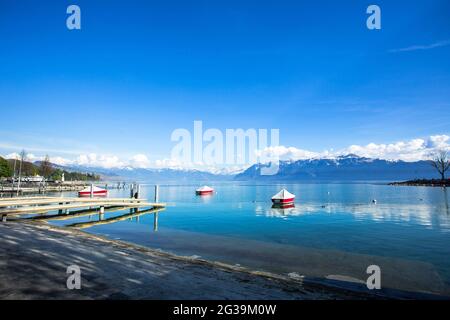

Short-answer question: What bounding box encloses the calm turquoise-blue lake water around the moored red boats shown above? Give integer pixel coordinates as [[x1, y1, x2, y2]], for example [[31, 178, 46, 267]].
[[45, 183, 450, 294]]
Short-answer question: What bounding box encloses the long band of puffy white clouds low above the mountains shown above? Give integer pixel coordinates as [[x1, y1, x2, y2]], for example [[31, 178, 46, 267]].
[[1, 135, 450, 173]]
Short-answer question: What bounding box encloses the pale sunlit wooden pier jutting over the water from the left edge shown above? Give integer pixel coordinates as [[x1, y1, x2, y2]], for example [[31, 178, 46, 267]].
[[0, 197, 165, 221]]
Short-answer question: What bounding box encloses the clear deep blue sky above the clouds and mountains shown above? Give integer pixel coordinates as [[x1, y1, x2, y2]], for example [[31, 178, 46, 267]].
[[0, 0, 450, 169]]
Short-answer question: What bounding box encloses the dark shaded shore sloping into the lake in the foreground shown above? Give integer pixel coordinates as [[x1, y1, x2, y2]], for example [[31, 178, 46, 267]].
[[0, 222, 384, 299]]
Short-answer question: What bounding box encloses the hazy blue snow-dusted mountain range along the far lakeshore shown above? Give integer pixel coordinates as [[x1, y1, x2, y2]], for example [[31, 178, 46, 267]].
[[47, 154, 438, 182]]
